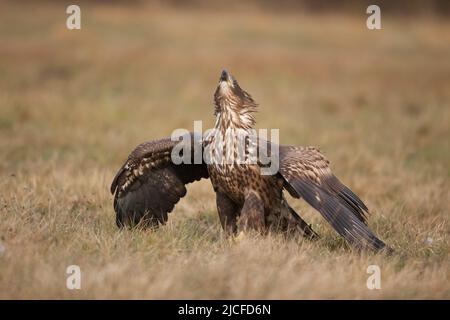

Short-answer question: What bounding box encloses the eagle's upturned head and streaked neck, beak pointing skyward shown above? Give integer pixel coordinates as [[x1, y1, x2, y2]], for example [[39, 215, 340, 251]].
[[214, 70, 257, 129]]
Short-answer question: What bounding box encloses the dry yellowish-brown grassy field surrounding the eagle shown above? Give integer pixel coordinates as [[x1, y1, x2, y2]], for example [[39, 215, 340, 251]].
[[0, 2, 450, 299]]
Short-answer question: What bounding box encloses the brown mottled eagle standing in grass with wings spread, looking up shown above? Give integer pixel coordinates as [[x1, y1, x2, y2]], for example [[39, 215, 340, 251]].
[[111, 70, 392, 252]]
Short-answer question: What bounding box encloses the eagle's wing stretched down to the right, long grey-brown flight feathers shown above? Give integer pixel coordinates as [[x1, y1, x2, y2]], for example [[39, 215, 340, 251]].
[[279, 146, 385, 251]]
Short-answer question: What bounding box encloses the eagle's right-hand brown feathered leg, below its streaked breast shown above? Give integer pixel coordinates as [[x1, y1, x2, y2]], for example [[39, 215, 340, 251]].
[[238, 191, 266, 232]]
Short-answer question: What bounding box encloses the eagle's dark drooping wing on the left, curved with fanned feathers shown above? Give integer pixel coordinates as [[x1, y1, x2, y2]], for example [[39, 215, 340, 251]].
[[111, 134, 209, 227]]
